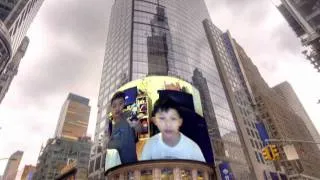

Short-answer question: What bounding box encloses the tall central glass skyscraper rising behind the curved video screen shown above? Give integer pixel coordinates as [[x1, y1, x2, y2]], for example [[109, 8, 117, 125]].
[[89, 0, 251, 179]]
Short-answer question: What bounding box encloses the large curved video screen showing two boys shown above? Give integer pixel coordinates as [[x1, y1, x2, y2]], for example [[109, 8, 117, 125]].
[[106, 76, 214, 170]]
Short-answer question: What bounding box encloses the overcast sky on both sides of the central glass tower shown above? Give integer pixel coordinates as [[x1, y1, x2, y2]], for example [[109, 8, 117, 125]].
[[0, 0, 320, 177]]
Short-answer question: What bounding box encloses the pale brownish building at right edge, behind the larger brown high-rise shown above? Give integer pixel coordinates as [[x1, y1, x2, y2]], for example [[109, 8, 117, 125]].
[[273, 82, 320, 149]]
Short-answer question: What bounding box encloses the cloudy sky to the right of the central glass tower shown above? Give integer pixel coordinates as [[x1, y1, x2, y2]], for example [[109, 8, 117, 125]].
[[206, 0, 320, 135]]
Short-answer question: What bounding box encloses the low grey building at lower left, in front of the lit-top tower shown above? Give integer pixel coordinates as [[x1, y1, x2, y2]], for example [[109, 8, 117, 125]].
[[32, 137, 92, 180]]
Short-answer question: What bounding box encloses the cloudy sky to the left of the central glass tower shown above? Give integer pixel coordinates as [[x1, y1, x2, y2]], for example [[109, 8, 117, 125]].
[[0, 0, 112, 174]]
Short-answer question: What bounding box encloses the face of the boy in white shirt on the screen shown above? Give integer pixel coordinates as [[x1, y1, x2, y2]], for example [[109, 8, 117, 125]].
[[154, 109, 182, 140]]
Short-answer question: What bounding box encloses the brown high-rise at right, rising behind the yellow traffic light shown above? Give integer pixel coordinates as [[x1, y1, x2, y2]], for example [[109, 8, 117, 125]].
[[236, 44, 320, 180]]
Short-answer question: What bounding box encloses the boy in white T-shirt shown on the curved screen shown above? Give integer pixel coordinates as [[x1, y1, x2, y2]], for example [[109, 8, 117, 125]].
[[141, 98, 205, 162]]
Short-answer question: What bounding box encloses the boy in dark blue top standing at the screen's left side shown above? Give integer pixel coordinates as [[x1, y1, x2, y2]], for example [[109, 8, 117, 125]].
[[108, 92, 138, 164]]
